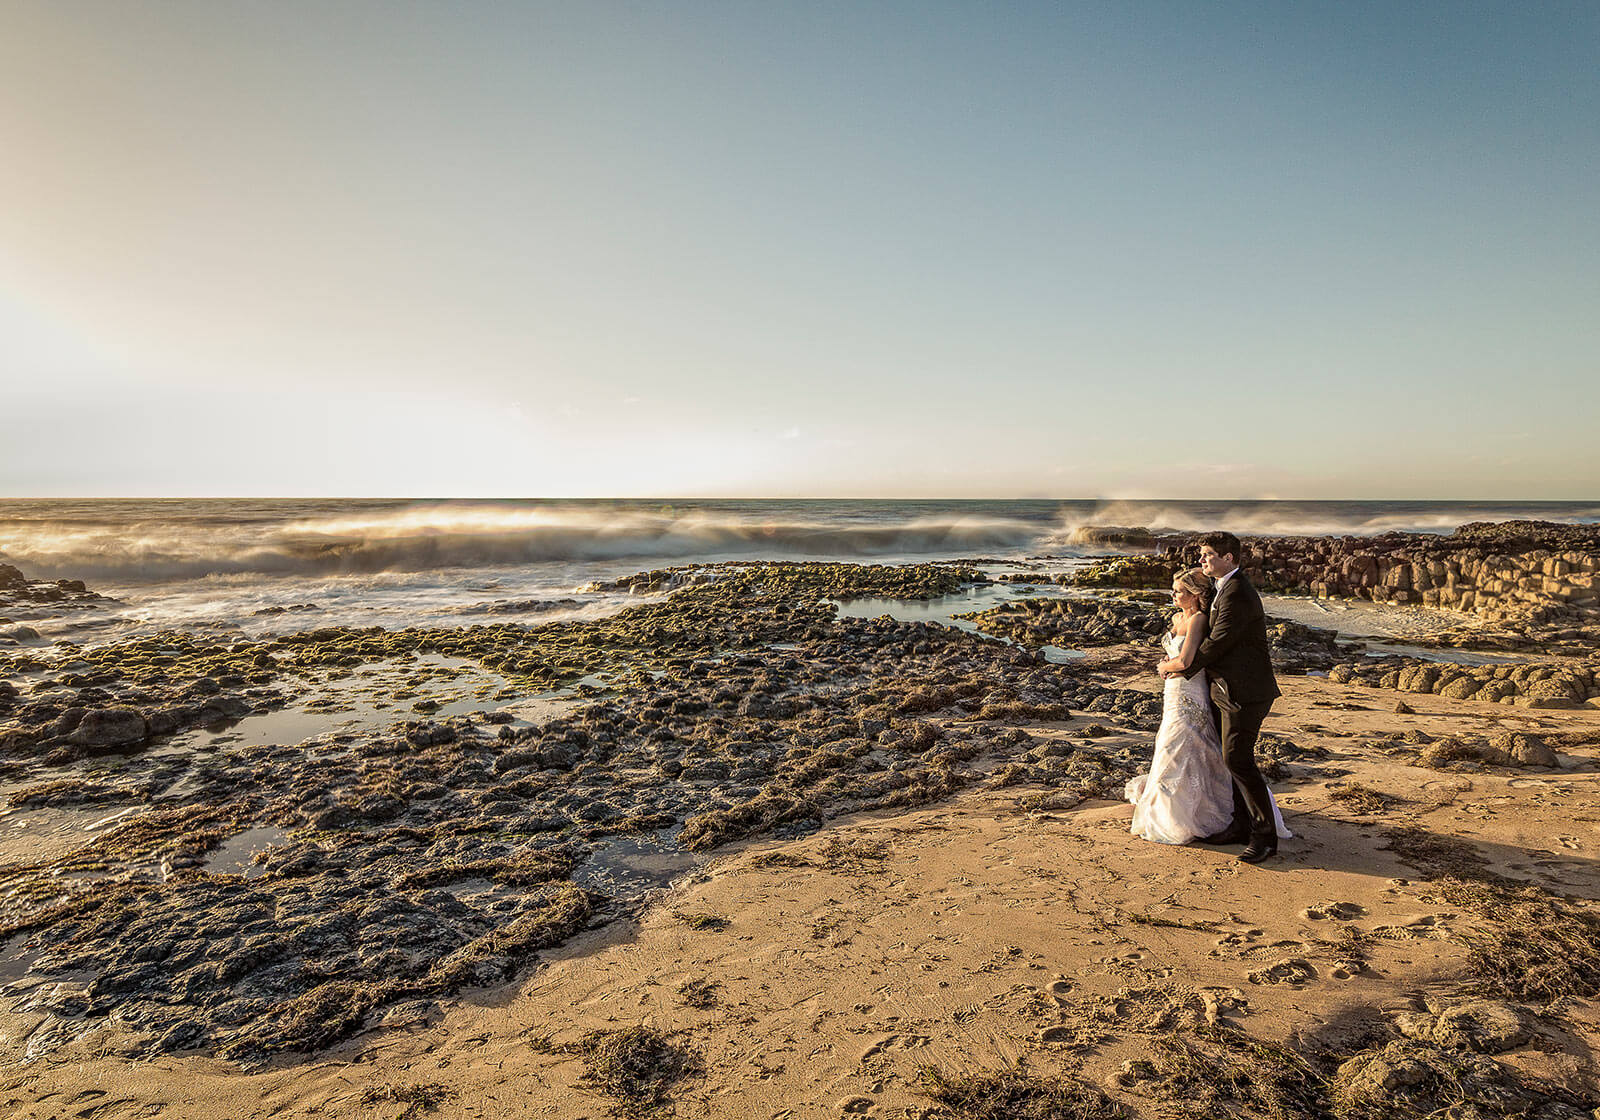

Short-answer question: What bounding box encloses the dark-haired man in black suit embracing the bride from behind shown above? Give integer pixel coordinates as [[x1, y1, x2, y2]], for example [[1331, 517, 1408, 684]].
[[1160, 533, 1282, 864]]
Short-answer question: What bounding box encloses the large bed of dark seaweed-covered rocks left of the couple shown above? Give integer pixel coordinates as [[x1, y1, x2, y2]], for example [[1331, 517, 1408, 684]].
[[0, 565, 1160, 1061]]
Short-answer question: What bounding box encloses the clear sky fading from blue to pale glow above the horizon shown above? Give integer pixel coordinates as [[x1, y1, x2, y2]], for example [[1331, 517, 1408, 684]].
[[0, 0, 1600, 499]]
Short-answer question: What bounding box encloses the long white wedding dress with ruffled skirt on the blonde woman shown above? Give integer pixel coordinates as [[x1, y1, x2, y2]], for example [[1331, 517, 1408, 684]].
[[1123, 634, 1293, 843]]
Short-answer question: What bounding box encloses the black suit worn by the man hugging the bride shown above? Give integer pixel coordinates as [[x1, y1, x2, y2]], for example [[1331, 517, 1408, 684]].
[[1184, 571, 1283, 843]]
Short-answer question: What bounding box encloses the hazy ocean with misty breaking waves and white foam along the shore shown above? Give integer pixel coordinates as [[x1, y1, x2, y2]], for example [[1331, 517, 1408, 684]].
[[0, 499, 1600, 643]]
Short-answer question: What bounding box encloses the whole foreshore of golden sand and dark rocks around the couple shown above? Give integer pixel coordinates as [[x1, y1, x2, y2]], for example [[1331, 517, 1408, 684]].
[[0, 521, 1600, 1120]]
